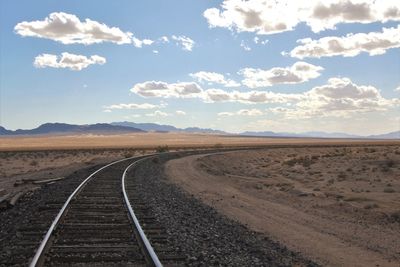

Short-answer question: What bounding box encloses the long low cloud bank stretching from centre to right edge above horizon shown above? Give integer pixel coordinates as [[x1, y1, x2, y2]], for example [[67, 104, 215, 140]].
[[132, 78, 400, 118]]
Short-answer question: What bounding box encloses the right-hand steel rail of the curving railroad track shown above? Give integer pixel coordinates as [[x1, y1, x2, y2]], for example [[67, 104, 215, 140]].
[[122, 157, 163, 267]]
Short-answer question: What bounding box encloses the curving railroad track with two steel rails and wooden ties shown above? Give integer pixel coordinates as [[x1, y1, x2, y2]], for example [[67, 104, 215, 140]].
[[30, 156, 185, 267]]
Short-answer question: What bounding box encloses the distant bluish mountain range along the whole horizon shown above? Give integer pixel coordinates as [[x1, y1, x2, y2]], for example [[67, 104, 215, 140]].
[[0, 121, 400, 139]]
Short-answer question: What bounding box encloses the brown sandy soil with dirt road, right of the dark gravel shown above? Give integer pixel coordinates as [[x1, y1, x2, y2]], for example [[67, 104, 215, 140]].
[[165, 146, 400, 266]]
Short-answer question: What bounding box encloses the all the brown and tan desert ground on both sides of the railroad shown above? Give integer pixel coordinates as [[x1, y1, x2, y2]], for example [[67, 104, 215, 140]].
[[0, 133, 400, 266]]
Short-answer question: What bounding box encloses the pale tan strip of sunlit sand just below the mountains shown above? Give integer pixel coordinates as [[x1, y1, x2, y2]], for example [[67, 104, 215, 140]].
[[0, 133, 394, 151]]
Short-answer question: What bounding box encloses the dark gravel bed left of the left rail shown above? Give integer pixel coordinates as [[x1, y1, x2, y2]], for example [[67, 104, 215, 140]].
[[0, 166, 100, 266]]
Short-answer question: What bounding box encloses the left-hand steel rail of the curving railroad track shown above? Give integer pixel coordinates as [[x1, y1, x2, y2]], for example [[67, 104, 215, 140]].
[[29, 155, 152, 267]]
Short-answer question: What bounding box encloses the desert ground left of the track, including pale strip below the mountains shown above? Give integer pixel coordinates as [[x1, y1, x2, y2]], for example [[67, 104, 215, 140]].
[[0, 133, 390, 199]]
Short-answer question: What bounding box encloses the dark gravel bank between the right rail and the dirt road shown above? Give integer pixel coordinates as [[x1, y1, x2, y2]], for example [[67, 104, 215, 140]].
[[127, 153, 317, 266]]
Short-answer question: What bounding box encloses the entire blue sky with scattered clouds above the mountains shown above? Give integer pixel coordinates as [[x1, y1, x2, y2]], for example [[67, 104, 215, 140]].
[[0, 0, 400, 135]]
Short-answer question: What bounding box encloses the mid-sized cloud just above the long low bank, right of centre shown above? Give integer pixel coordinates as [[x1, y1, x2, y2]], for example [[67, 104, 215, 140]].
[[239, 62, 323, 88]]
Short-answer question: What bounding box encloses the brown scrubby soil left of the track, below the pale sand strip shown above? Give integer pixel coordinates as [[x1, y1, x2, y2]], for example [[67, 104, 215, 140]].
[[0, 149, 147, 198]]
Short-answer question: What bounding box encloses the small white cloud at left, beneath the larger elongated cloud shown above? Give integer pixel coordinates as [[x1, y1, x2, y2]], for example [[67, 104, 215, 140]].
[[33, 52, 106, 71]]
